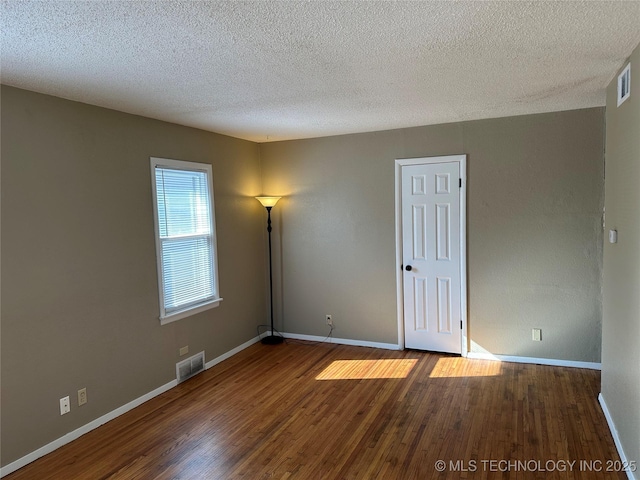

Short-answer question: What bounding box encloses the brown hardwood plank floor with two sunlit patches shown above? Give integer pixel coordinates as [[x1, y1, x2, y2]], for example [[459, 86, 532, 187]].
[[5, 342, 627, 480]]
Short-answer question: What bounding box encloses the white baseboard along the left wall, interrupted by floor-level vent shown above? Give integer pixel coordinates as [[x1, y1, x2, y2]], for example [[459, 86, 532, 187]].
[[0, 337, 260, 478]]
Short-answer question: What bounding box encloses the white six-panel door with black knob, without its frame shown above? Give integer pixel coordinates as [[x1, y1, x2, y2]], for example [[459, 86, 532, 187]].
[[401, 162, 462, 353]]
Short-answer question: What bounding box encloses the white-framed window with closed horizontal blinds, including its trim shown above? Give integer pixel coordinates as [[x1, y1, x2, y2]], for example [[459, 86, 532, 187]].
[[151, 157, 222, 324]]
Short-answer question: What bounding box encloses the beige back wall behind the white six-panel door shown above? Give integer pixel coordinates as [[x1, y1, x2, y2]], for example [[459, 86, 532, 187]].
[[260, 108, 604, 362]]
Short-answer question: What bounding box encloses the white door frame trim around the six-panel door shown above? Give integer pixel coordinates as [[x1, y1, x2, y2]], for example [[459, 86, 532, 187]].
[[395, 154, 469, 357]]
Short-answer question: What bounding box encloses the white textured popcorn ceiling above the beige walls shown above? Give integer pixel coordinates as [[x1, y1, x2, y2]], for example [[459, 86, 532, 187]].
[[0, 0, 640, 142]]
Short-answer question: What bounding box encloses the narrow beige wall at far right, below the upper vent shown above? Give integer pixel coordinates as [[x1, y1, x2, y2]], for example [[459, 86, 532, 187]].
[[602, 43, 640, 478]]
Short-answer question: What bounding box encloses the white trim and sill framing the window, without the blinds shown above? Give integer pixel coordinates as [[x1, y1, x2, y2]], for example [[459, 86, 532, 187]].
[[150, 157, 222, 325]]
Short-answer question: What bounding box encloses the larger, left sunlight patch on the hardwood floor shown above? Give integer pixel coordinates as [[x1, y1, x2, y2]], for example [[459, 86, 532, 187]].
[[316, 358, 418, 380]]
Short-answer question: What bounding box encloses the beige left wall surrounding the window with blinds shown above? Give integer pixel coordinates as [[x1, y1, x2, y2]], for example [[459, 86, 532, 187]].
[[1, 86, 267, 465]]
